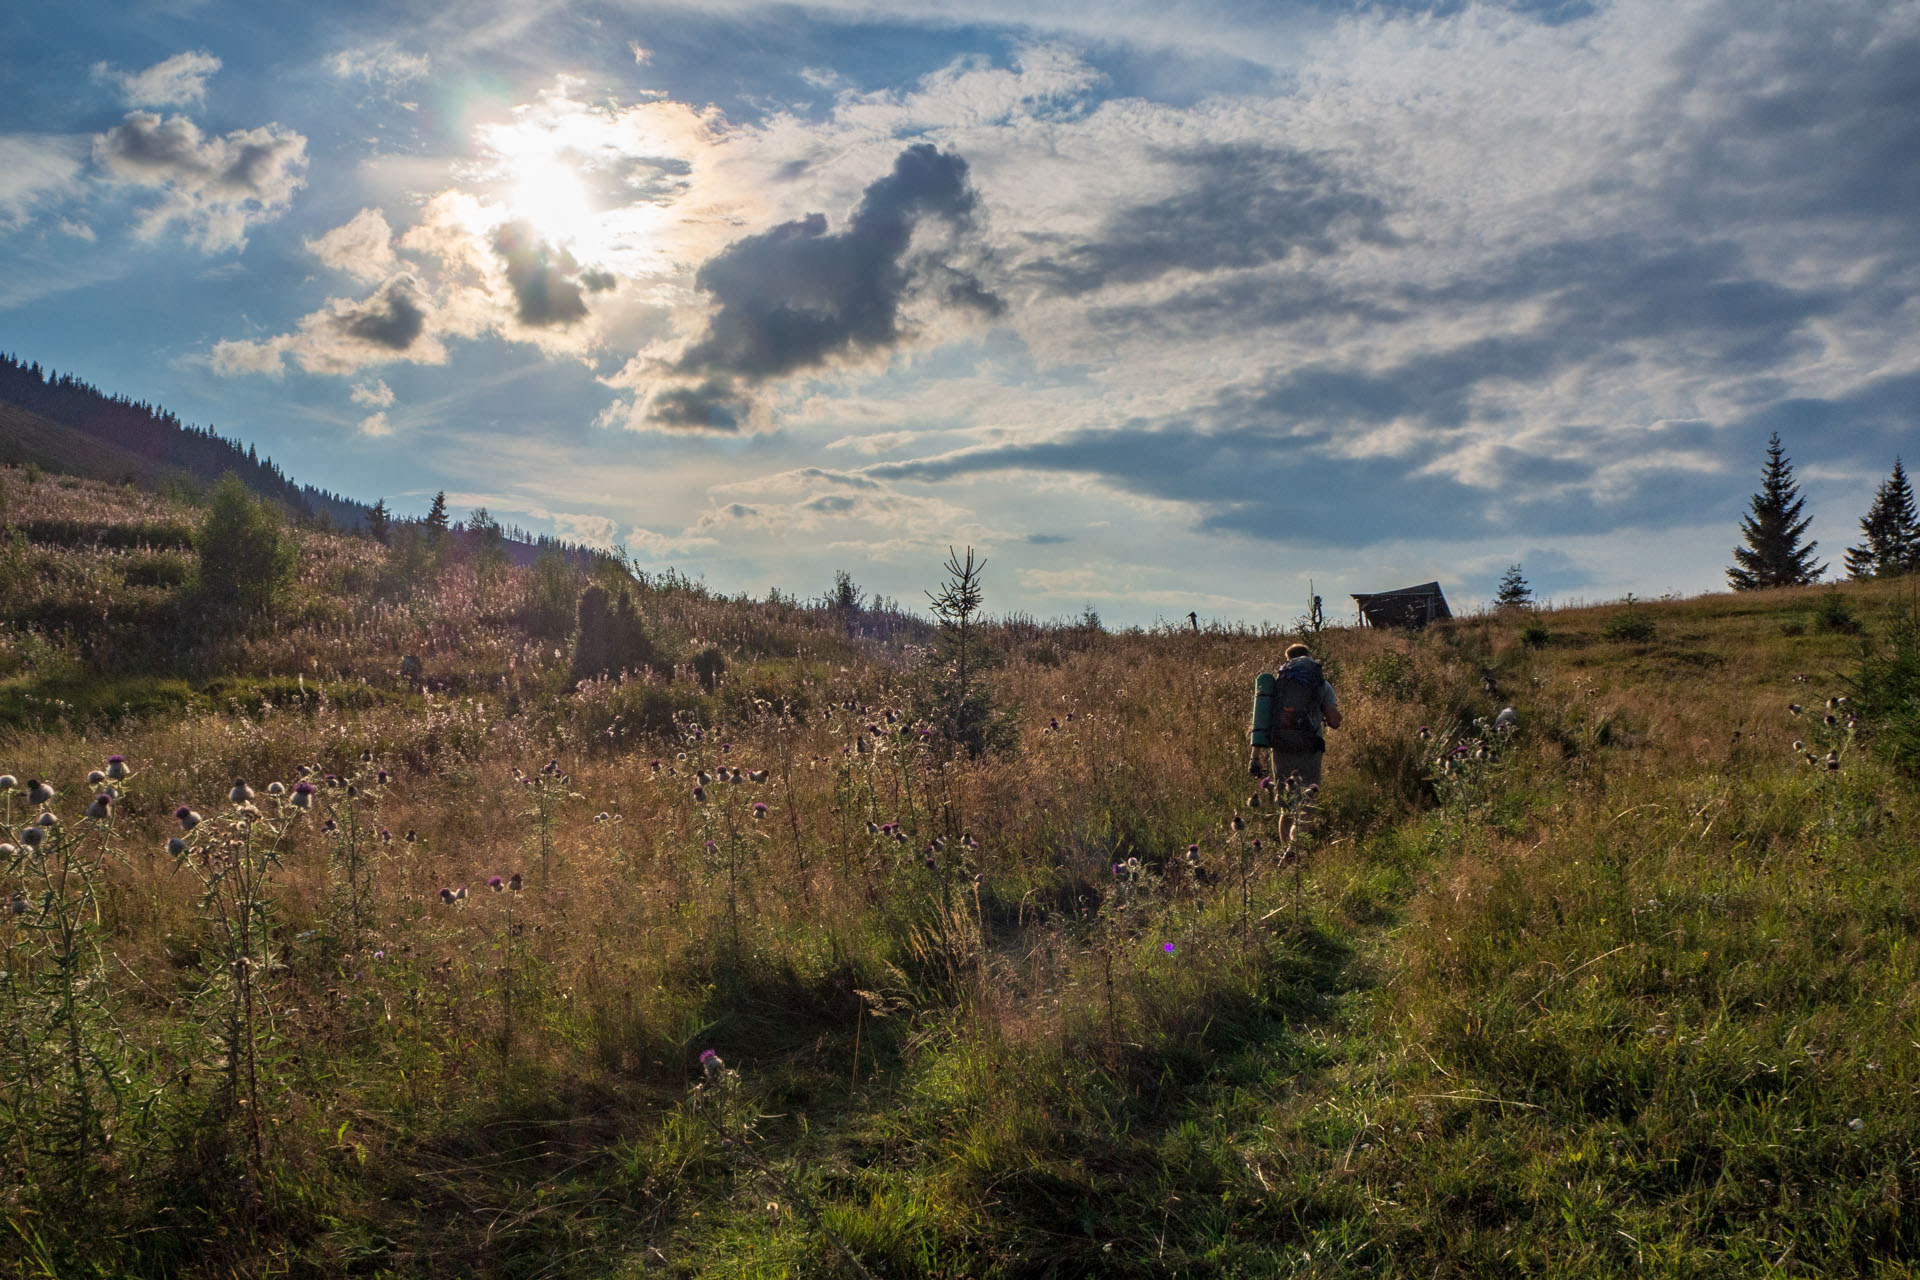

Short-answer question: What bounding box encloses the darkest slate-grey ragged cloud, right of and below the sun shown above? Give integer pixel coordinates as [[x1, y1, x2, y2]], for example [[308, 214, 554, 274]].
[[651, 142, 1004, 430]]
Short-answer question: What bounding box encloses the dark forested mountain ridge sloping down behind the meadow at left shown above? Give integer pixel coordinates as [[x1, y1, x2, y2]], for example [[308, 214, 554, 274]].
[[0, 353, 371, 530]]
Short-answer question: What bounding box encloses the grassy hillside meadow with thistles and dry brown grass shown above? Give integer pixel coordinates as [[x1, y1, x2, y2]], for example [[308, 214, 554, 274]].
[[0, 472, 1920, 1278]]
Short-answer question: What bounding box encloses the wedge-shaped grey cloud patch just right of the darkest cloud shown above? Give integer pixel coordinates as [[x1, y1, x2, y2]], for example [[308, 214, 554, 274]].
[[1029, 146, 1398, 296]]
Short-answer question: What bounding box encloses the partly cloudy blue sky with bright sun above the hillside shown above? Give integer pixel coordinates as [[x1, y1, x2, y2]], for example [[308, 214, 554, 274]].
[[0, 0, 1920, 624]]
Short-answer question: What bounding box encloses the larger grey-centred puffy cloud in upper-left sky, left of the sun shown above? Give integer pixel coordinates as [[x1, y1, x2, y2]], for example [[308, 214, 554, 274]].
[[94, 111, 307, 253]]
